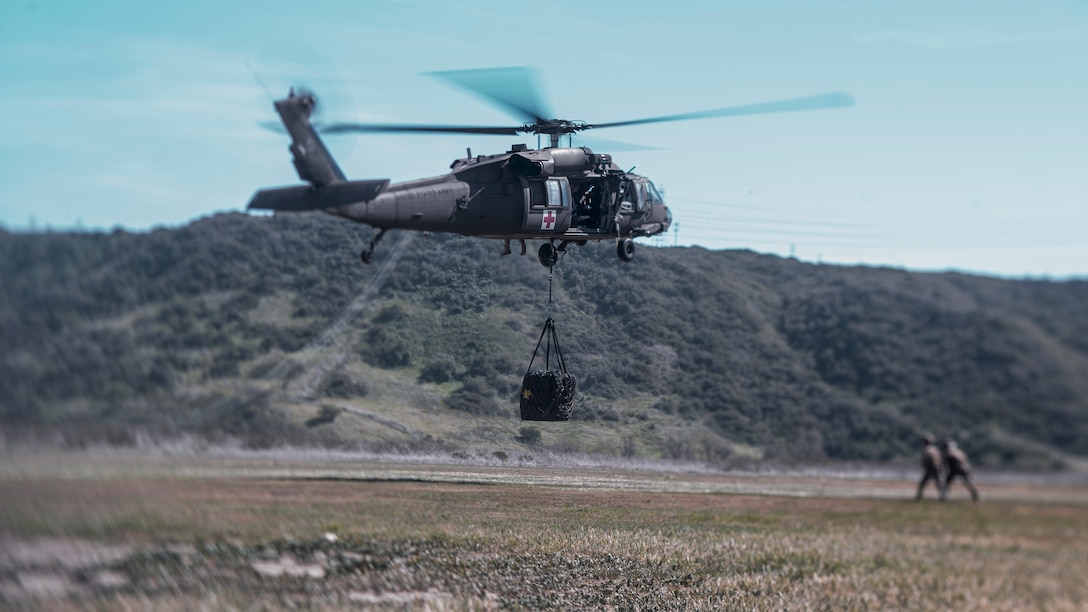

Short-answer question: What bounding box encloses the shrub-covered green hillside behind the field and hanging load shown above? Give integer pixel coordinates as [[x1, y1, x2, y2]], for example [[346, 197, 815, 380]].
[[0, 215, 1088, 467]]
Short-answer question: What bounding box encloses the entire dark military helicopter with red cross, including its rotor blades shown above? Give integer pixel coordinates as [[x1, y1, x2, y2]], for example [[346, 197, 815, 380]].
[[248, 68, 853, 267]]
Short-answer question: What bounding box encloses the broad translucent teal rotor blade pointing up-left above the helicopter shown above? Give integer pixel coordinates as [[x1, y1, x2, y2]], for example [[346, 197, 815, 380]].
[[426, 66, 553, 123]]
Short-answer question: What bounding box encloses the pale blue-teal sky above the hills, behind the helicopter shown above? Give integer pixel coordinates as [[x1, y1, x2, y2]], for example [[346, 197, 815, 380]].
[[0, 0, 1088, 279]]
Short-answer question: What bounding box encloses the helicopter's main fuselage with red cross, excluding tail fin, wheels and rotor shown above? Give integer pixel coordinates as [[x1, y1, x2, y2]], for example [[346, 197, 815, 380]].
[[327, 147, 671, 242]]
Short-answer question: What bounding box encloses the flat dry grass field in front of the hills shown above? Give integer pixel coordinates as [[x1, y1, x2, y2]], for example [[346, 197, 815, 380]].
[[0, 452, 1088, 610]]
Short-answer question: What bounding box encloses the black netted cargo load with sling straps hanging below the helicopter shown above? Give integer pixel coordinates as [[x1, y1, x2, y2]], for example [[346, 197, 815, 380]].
[[521, 317, 576, 420]]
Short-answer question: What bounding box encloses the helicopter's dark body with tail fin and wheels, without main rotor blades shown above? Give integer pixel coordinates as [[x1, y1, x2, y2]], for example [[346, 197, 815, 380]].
[[249, 91, 671, 266]]
